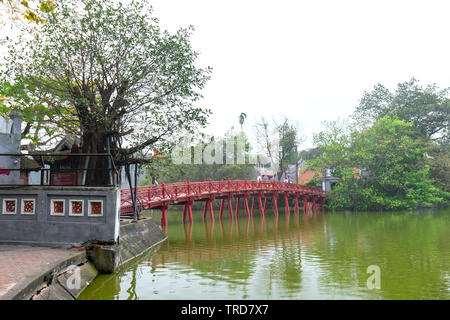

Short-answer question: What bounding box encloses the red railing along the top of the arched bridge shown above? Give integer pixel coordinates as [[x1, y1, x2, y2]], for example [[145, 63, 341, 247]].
[[121, 180, 323, 208]]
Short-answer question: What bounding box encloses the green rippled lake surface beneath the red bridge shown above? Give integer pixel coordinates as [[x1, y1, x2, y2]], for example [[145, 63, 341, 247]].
[[79, 210, 450, 300]]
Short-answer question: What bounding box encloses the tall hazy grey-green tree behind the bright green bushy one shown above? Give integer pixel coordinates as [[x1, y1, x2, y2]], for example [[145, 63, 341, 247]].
[[353, 78, 450, 190]]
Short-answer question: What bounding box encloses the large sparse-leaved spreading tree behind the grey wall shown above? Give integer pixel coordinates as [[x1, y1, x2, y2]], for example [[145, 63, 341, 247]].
[[3, 0, 210, 184]]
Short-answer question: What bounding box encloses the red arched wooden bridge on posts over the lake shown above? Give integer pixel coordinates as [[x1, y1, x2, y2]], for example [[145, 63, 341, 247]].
[[120, 180, 326, 226]]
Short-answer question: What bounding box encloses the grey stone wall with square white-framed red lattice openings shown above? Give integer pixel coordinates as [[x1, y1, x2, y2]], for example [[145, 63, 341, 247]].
[[0, 186, 120, 245]]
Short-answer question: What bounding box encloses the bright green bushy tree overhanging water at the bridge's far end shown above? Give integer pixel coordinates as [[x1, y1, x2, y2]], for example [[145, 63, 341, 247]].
[[308, 116, 448, 210]]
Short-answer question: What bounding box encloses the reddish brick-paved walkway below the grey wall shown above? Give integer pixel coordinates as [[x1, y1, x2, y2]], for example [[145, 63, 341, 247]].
[[0, 245, 80, 300]]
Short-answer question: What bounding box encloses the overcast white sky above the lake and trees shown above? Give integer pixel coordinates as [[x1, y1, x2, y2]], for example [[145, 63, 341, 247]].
[[150, 0, 450, 147]]
